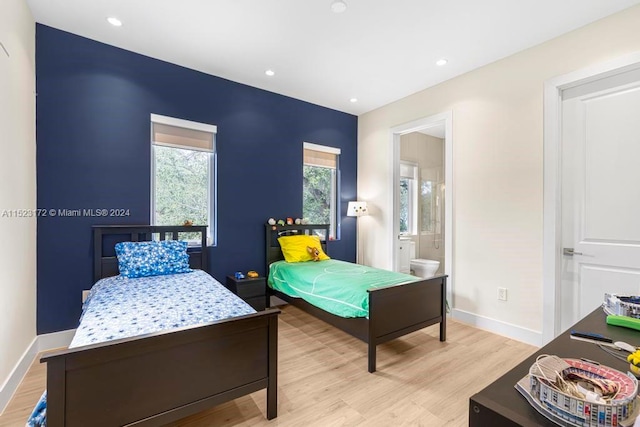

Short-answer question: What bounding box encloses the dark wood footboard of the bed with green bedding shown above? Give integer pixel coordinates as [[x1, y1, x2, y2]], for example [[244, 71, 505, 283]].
[[367, 276, 447, 372]]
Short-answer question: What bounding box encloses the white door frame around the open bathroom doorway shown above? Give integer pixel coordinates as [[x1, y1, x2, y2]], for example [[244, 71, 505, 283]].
[[388, 111, 454, 304]]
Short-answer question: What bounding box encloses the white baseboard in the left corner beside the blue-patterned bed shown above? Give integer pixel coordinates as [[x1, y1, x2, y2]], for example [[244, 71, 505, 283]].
[[0, 329, 76, 414]]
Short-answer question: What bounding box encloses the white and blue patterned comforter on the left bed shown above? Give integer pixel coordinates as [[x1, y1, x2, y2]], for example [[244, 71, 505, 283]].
[[27, 270, 256, 427]]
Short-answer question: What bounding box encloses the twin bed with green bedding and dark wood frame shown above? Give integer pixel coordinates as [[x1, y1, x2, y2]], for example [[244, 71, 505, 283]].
[[265, 225, 446, 372]]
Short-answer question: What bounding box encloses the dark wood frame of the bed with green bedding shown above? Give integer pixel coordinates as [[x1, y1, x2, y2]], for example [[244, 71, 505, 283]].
[[265, 224, 447, 372]]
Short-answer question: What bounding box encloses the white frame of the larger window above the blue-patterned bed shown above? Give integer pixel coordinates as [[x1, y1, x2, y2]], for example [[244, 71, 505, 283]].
[[150, 113, 218, 246]]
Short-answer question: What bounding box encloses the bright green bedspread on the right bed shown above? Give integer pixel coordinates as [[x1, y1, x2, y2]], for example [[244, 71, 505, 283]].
[[269, 259, 419, 317]]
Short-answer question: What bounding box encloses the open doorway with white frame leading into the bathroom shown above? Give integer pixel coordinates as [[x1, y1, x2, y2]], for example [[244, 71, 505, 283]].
[[392, 113, 453, 301]]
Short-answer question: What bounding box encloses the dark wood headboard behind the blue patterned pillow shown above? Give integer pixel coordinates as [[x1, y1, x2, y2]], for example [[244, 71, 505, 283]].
[[93, 225, 208, 283]]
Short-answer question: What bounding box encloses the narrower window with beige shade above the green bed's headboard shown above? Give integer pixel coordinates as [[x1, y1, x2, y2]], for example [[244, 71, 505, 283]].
[[302, 142, 340, 239]]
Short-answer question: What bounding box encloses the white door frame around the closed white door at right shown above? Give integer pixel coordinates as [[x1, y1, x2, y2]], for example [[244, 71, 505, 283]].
[[542, 52, 640, 344]]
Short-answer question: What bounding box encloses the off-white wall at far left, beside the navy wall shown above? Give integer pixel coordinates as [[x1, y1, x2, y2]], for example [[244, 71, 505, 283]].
[[0, 0, 36, 411]]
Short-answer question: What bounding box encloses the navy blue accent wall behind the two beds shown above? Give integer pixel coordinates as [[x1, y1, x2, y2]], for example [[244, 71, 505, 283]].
[[36, 24, 357, 334]]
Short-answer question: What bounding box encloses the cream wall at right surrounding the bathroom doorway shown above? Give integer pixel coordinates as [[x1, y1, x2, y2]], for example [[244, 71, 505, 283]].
[[358, 6, 640, 342]]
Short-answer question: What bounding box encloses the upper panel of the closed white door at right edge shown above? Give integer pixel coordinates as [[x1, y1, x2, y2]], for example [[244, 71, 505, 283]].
[[581, 88, 640, 244]]
